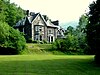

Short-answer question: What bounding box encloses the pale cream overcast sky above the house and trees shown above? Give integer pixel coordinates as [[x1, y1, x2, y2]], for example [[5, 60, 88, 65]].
[[10, 0, 95, 23]]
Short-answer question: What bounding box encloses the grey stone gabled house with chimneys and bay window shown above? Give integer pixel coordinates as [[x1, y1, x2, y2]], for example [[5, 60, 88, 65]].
[[14, 11, 64, 42]]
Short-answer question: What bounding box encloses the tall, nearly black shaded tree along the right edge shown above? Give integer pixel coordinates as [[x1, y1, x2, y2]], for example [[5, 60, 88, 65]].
[[86, 0, 100, 64]]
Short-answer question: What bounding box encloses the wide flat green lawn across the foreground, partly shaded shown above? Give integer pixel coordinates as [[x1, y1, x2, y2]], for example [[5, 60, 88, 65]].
[[0, 55, 100, 75]]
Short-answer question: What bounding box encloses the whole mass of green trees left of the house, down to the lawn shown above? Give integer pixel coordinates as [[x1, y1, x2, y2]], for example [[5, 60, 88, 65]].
[[0, 0, 26, 54]]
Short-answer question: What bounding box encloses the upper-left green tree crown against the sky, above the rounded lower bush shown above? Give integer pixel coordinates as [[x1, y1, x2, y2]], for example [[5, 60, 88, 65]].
[[0, 0, 25, 26]]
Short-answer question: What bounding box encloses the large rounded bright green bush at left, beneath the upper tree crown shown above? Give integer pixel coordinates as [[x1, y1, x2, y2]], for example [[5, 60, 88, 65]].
[[0, 22, 26, 53]]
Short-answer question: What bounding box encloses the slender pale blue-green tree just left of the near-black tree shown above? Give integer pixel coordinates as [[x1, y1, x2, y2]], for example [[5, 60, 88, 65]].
[[76, 14, 91, 54]]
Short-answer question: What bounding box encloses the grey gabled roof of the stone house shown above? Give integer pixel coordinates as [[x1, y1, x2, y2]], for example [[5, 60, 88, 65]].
[[15, 13, 58, 28]]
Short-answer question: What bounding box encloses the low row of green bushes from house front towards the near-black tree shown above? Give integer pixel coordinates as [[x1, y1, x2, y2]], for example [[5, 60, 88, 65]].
[[53, 34, 88, 54]]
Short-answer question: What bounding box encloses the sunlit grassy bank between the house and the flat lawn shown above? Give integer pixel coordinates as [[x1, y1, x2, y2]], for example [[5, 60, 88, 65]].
[[22, 43, 52, 54]]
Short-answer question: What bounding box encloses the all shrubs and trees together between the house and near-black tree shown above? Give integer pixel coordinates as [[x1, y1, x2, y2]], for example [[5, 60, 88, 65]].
[[53, 14, 88, 54]]
